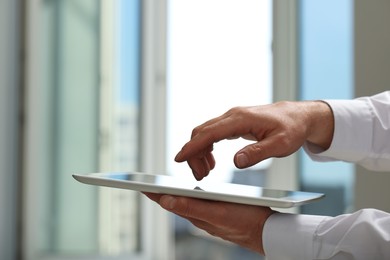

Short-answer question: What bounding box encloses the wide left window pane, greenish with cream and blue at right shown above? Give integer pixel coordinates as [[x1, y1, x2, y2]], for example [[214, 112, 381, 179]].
[[33, 0, 140, 259]]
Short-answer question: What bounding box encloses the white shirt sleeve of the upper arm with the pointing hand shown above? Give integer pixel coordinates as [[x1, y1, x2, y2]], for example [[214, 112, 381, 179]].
[[304, 91, 390, 171]]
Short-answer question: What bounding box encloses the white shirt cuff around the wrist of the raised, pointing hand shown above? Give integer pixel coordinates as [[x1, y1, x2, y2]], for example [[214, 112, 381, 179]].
[[303, 98, 373, 162]]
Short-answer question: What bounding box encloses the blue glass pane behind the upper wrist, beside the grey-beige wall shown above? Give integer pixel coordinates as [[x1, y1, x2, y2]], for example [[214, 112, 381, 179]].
[[299, 0, 353, 215]]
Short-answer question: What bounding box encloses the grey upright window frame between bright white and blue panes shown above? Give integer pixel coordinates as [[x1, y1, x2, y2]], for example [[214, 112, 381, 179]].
[[267, 0, 299, 195]]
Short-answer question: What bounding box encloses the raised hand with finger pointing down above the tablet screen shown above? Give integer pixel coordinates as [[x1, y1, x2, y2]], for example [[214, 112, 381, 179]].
[[175, 101, 334, 180]]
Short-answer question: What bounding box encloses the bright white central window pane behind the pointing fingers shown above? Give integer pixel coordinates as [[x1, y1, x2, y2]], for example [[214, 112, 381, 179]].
[[167, 0, 272, 259]]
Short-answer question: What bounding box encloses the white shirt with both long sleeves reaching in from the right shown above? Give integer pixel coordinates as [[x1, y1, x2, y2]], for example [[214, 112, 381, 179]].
[[263, 91, 390, 260]]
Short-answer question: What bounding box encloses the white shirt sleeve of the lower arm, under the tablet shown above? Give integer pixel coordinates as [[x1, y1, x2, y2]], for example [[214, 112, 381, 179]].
[[263, 209, 390, 260]]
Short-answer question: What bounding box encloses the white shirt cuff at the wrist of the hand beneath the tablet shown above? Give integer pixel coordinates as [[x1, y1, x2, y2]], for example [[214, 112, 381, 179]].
[[263, 213, 329, 260]]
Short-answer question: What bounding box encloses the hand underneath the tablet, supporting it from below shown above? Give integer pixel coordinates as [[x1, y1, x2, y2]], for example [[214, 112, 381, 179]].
[[145, 193, 274, 255]]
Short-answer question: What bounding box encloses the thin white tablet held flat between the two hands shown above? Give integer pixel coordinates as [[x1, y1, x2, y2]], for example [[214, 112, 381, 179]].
[[73, 172, 324, 208]]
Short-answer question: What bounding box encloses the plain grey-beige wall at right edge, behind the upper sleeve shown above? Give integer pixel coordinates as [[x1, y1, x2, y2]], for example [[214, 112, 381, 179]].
[[355, 0, 390, 212]]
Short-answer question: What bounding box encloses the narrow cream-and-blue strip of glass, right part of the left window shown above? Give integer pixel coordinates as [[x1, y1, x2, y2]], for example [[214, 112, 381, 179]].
[[99, 0, 140, 254]]
